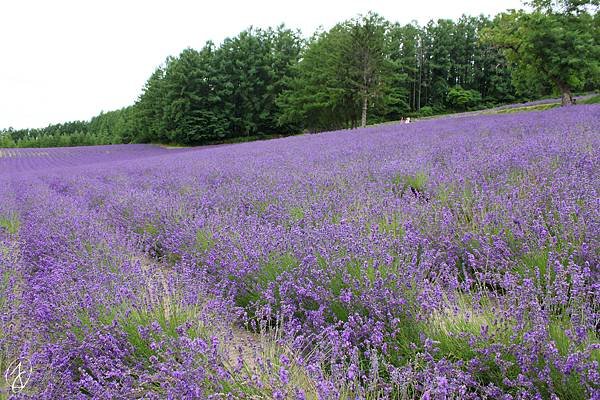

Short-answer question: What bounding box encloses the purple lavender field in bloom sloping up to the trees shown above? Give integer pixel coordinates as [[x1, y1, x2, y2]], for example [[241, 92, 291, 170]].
[[0, 105, 600, 399]]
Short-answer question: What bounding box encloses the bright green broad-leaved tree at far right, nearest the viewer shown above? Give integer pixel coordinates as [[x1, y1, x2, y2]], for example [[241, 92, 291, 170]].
[[485, 0, 600, 105]]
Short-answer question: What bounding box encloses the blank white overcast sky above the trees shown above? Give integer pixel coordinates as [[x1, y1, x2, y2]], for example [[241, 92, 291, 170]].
[[0, 0, 521, 128]]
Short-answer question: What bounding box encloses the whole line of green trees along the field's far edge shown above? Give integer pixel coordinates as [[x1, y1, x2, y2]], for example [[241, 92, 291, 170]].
[[0, 0, 600, 147]]
